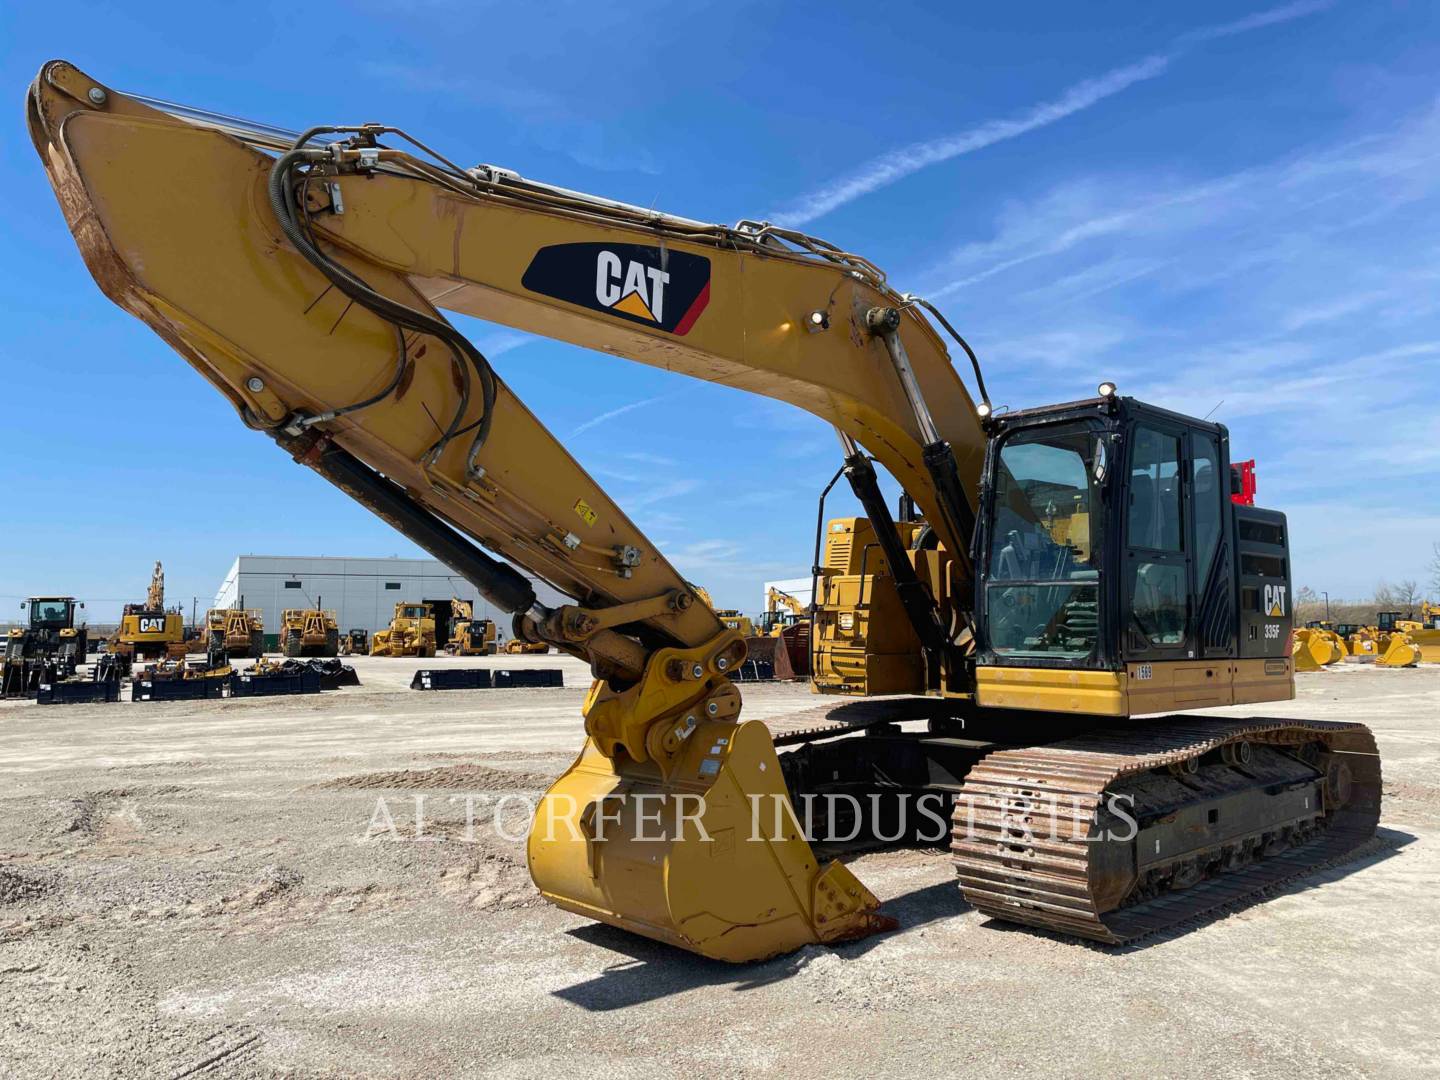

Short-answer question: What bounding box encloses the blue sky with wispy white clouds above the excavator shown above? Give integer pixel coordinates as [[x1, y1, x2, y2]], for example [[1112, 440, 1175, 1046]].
[[0, 0, 1440, 619]]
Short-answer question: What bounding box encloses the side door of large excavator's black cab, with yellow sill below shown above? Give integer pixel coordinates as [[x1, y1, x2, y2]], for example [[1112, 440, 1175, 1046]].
[[1120, 415, 1233, 716]]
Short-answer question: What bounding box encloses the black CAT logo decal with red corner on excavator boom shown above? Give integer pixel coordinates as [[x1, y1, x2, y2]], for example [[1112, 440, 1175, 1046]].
[[520, 243, 710, 337]]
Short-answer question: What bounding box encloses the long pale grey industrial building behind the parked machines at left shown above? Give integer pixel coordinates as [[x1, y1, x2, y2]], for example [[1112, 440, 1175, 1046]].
[[215, 554, 567, 638]]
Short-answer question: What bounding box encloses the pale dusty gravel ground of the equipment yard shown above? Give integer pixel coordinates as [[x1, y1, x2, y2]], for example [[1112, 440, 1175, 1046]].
[[0, 657, 1440, 1077]]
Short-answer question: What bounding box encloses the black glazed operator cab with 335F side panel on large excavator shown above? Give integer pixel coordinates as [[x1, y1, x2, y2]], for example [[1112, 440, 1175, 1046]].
[[975, 393, 1292, 714]]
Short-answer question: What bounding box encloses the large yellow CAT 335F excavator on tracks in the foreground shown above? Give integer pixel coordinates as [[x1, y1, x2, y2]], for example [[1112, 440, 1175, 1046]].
[[27, 62, 1380, 960]]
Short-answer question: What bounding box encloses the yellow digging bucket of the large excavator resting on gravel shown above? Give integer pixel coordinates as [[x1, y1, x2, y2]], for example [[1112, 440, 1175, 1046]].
[[528, 721, 896, 962]]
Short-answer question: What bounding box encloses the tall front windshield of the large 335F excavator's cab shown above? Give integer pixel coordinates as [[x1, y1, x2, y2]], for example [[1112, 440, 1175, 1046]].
[[985, 425, 1104, 660]]
